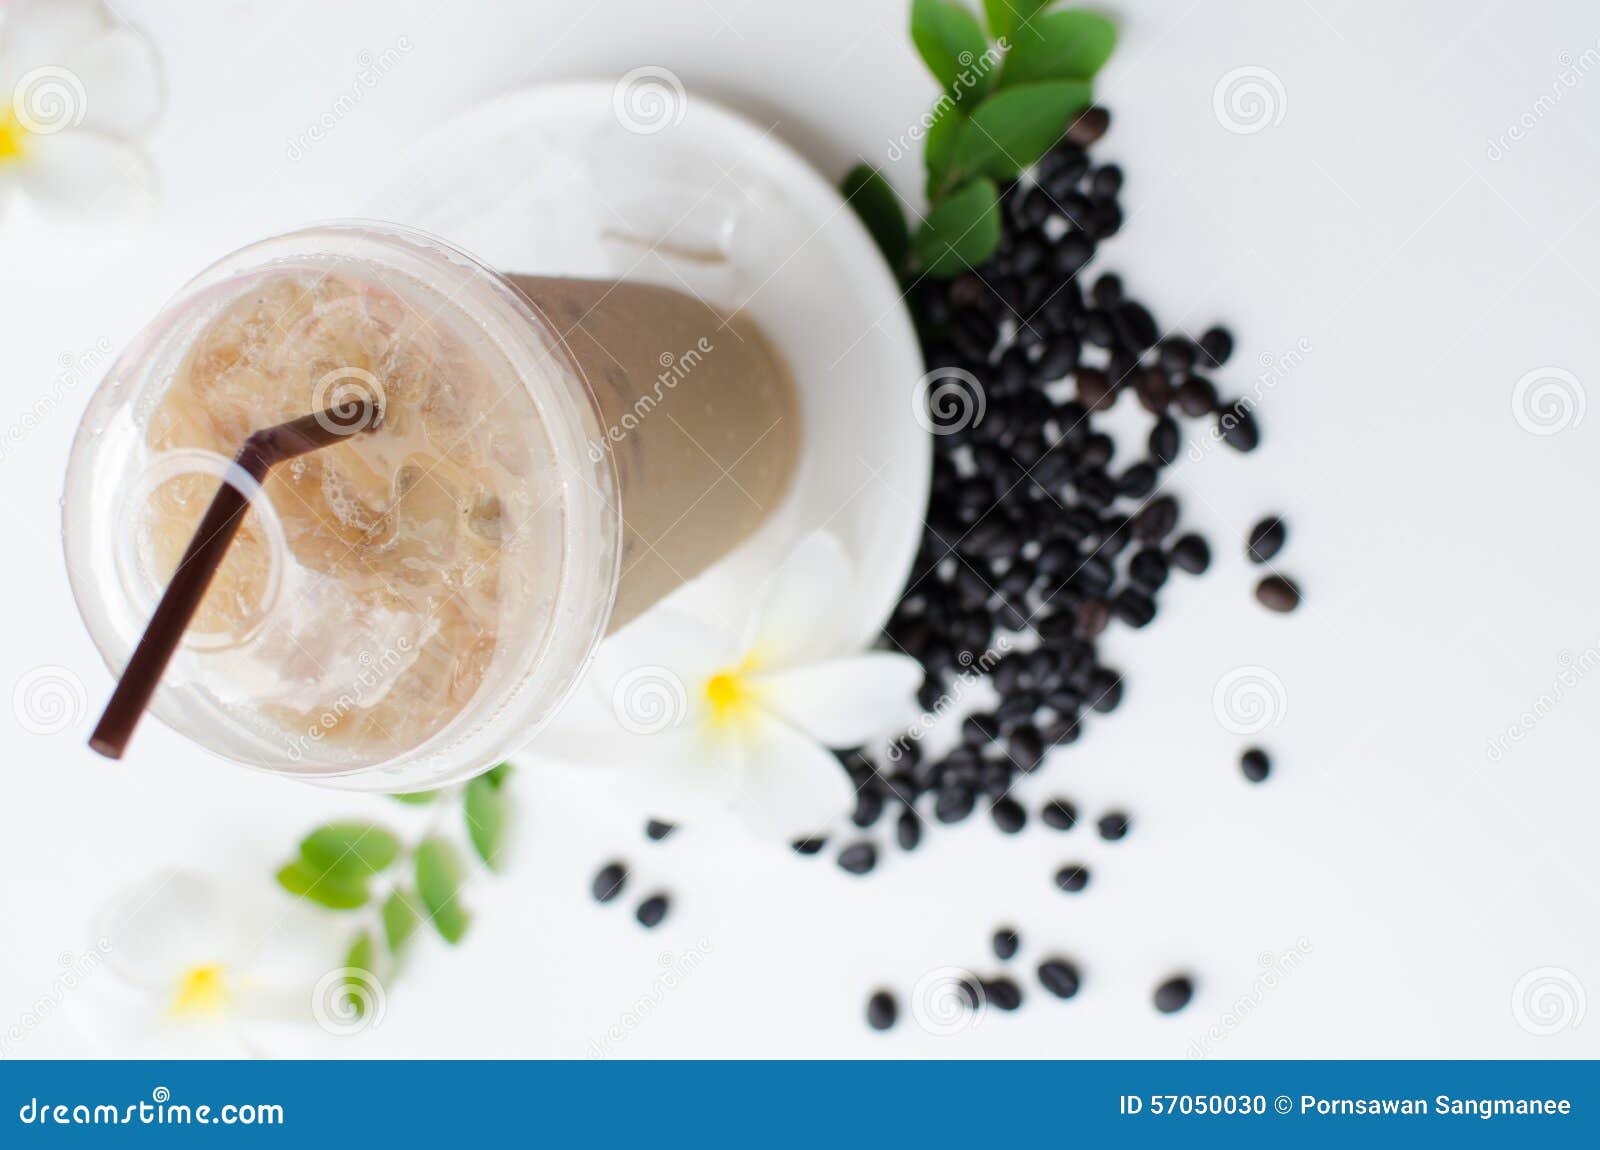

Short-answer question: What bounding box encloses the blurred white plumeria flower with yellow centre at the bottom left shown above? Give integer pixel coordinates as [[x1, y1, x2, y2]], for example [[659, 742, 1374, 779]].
[[96, 872, 338, 1054]]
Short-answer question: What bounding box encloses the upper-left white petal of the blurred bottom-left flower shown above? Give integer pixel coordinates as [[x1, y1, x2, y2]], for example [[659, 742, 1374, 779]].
[[96, 870, 243, 996]]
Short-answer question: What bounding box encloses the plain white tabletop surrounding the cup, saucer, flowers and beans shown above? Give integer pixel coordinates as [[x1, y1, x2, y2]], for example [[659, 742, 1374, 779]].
[[0, 0, 1600, 1057]]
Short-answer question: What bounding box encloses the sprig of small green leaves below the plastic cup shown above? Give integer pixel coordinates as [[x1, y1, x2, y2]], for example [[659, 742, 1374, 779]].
[[268, 763, 512, 1016]]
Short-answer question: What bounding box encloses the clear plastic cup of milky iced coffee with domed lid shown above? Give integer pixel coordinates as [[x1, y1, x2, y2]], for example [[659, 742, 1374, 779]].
[[67, 229, 800, 787]]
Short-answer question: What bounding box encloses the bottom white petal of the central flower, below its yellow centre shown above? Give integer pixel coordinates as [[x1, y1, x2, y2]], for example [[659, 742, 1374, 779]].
[[733, 717, 854, 840]]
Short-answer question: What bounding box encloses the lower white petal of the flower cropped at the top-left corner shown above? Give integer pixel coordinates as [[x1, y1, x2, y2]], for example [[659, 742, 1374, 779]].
[[16, 131, 155, 219]]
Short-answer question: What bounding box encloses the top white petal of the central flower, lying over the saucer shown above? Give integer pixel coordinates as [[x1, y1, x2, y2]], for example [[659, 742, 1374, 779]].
[[746, 531, 854, 667]]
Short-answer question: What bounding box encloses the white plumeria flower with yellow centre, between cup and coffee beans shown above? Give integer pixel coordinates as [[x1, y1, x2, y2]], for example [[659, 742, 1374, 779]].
[[534, 531, 922, 838]]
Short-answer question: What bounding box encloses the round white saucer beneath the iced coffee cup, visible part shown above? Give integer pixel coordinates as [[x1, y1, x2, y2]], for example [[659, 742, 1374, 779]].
[[371, 83, 931, 643]]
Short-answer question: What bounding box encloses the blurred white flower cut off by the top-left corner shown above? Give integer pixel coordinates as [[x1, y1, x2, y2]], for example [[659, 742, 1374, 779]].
[[0, 0, 162, 216]]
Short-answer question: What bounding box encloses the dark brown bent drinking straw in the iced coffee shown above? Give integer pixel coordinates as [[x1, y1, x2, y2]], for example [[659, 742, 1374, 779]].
[[90, 403, 382, 758]]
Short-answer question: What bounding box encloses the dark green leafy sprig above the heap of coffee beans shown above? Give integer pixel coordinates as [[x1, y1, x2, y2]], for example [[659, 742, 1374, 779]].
[[843, 0, 1117, 282]]
